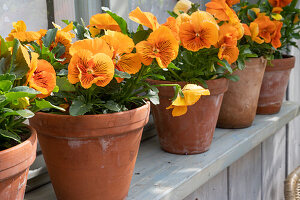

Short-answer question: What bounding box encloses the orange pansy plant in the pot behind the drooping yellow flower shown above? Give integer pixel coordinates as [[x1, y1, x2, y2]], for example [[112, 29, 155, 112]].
[[145, 0, 250, 86]]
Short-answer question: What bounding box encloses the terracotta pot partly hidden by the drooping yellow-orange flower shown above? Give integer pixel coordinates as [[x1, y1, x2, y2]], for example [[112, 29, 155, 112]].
[[149, 78, 228, 154]]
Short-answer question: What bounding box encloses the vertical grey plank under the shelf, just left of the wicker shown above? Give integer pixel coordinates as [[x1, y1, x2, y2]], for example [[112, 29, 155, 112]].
[[262, 127, 286, 200]]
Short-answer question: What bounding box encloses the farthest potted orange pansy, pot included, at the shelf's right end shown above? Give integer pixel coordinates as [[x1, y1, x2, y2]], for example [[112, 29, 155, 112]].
[[256, 0, 300, 114]]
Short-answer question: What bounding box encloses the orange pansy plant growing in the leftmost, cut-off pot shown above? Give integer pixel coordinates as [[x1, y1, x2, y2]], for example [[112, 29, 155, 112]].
[[0, 35, 63, 151]]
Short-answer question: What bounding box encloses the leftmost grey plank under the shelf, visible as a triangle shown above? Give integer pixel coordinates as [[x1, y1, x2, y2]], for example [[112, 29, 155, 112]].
[[184, 169, 228, 200]]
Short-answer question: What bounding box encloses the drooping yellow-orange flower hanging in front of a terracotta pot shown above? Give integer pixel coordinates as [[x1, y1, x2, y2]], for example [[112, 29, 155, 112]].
[[166, 84, 210, 117]]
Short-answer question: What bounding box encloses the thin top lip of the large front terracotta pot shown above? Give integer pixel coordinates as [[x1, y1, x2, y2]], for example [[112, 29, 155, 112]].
[[36, 101, 150, 119]]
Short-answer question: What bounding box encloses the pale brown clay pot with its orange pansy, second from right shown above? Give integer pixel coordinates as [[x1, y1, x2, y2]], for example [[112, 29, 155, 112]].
[[214, 1, 281, 128]]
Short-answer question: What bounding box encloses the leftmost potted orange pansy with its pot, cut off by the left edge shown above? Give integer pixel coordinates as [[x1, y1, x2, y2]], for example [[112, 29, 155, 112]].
[[0, 34, 63, 200]]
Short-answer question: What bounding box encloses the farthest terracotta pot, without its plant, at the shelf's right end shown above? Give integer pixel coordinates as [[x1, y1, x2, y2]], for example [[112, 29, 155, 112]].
[[257, 56, 295, 114]]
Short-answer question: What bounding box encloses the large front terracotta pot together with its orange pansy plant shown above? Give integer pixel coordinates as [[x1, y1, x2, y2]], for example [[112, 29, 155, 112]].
[[15, 8, 202, 200]]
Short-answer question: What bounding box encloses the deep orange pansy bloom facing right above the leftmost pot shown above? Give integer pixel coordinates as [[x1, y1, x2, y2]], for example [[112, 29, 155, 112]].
[[27, 53, 56, 98]]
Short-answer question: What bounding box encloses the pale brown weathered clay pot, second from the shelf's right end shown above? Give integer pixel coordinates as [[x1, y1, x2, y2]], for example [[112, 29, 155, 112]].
[[217, 57, 267, 128]]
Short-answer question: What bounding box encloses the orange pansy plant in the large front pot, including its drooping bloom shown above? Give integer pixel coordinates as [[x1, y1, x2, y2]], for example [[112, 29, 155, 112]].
[[8, 8, 207, 116]]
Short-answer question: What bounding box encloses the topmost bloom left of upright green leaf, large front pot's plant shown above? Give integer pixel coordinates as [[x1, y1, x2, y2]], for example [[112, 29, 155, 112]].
[[88, 13, 121, 31]]
